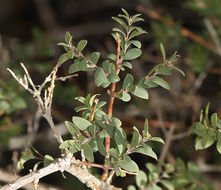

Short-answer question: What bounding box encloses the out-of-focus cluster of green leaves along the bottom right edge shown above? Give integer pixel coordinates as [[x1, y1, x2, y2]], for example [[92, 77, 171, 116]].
[[128, 158, 214, 190]]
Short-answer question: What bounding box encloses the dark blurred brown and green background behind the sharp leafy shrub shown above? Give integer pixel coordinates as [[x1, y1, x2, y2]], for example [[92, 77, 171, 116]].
[[0, 0, 221, 189]]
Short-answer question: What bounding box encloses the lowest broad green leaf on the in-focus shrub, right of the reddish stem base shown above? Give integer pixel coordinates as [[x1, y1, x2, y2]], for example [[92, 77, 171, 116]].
[[117, 155, 139, 172]]
